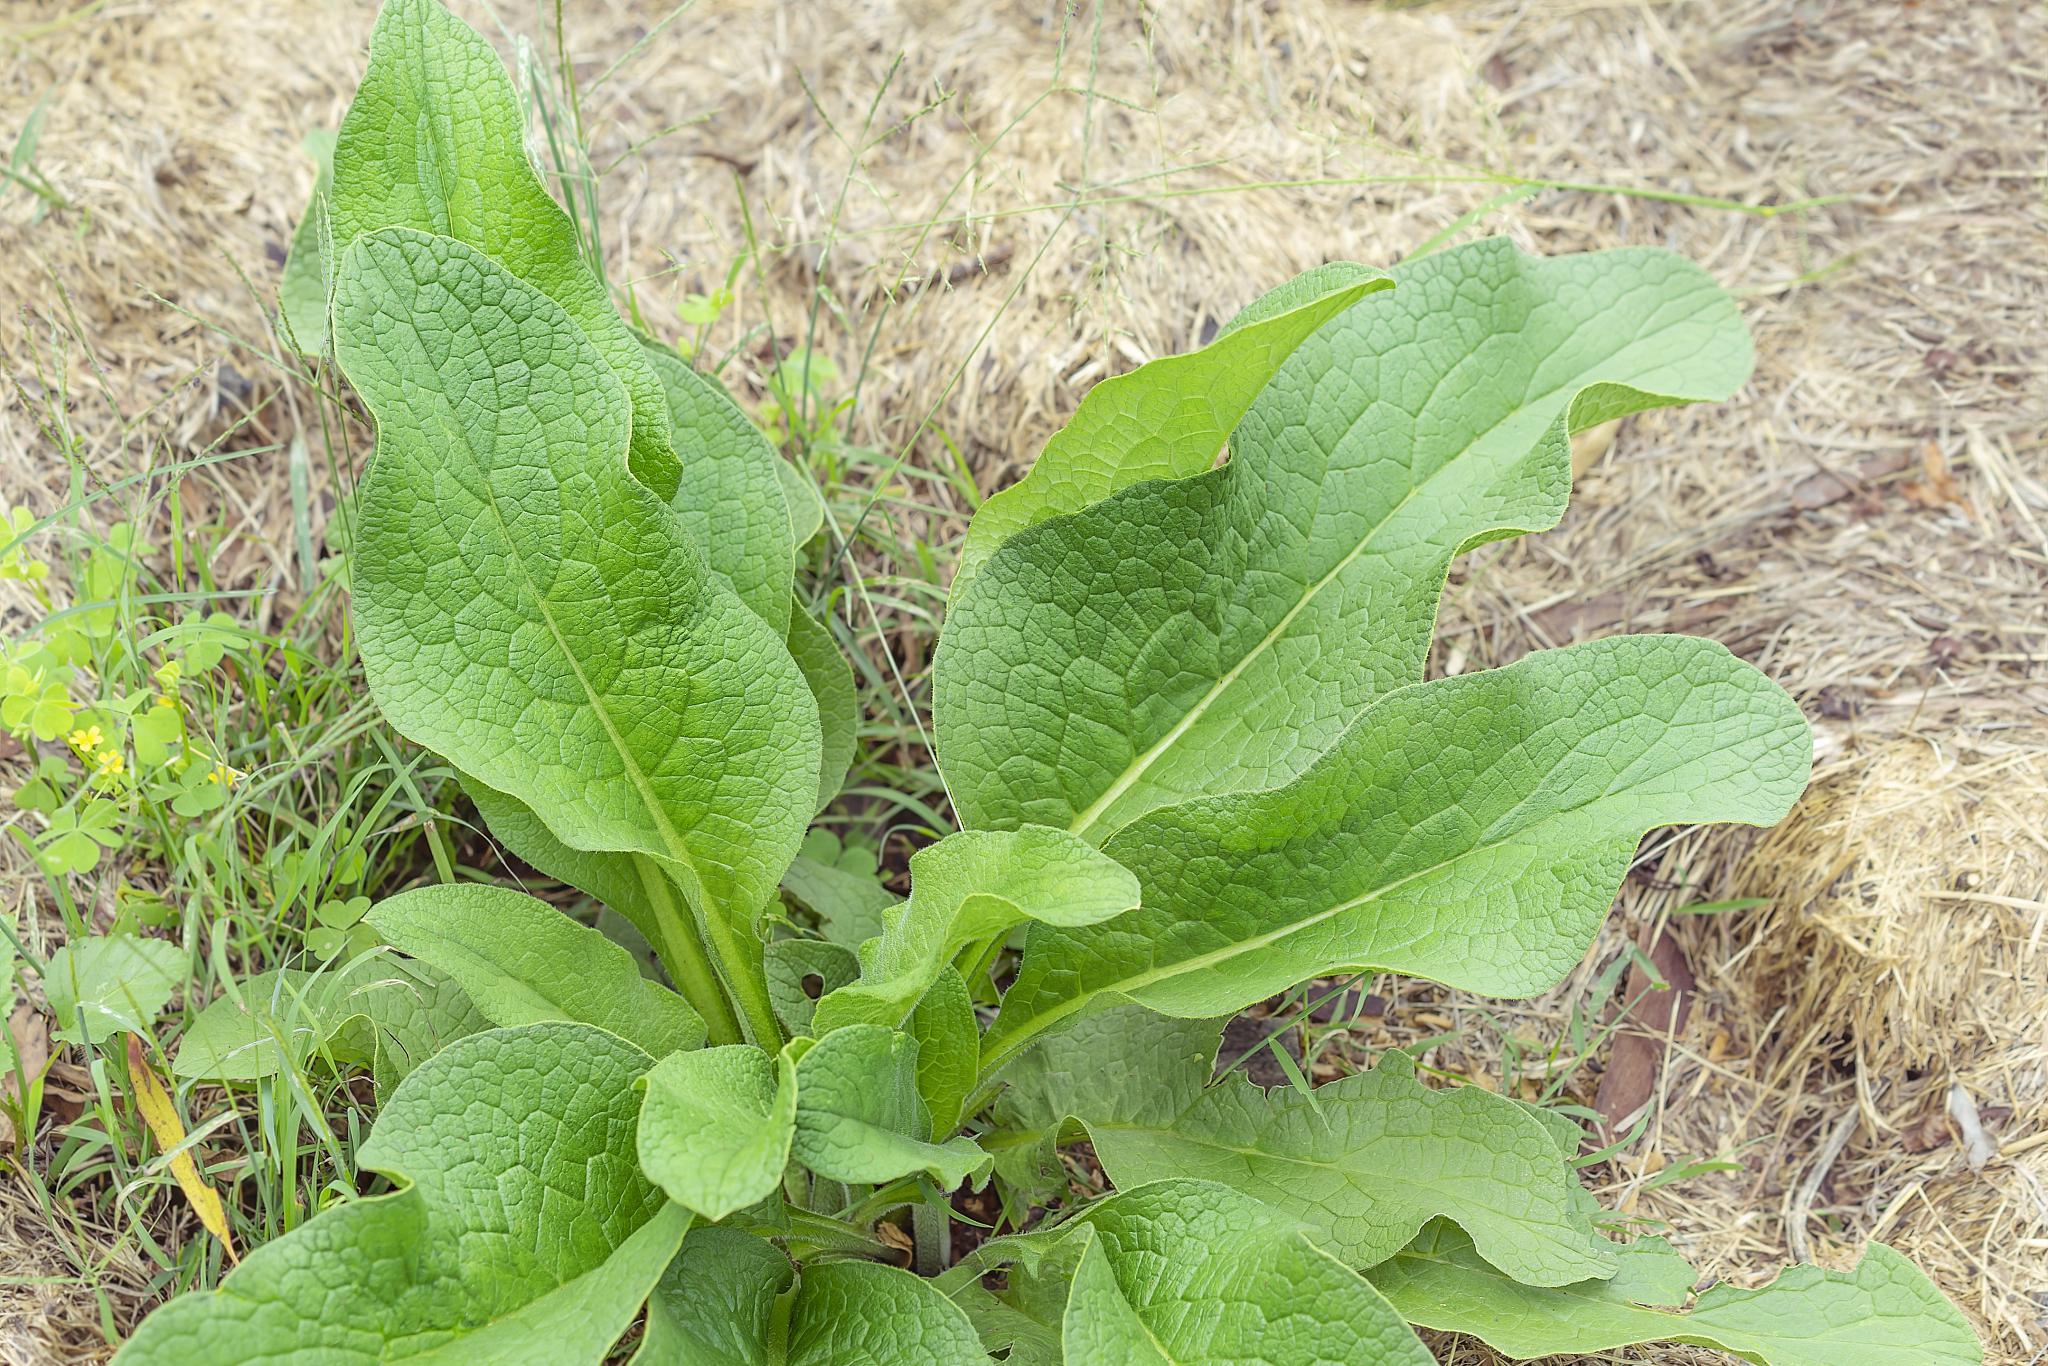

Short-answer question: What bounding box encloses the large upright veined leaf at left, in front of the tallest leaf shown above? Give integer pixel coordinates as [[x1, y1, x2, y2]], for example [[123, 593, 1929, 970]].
[[334, 229, 819, 1014]]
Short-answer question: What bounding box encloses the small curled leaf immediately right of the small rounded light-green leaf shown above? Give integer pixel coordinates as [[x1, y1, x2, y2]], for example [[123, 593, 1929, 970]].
[[791, 1024, 989, 1190]]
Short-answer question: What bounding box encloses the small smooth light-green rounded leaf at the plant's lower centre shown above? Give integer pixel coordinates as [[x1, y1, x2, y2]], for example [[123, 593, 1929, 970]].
[[637, 1044, 797, 1221]]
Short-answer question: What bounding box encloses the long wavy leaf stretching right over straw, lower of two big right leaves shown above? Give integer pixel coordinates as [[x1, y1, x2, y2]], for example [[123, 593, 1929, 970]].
[[983, 635, 1812, 1065]]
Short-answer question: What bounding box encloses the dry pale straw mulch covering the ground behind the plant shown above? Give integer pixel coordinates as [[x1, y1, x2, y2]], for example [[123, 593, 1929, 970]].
[[0, 0, 2048, 1362]]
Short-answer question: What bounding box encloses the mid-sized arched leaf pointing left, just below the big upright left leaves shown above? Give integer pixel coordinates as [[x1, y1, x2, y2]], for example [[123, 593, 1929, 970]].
[[365, 883, 705, 1057]]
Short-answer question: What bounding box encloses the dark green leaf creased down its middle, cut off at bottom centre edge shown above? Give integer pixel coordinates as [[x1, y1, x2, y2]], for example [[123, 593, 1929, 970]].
[[633, 1229, 989, 1366]]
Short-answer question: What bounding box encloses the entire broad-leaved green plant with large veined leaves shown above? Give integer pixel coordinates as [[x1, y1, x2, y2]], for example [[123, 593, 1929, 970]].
[[121, 0, 1978, 1366]]
